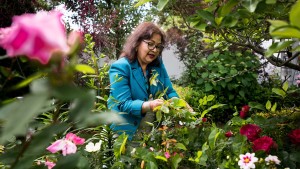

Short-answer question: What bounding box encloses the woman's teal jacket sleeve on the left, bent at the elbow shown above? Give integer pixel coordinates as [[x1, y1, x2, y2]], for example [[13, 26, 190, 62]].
[[109, 62, 144, 117]]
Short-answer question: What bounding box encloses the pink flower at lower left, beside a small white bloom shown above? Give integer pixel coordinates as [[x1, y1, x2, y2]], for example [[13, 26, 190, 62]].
[[47, 133, 85, 156]]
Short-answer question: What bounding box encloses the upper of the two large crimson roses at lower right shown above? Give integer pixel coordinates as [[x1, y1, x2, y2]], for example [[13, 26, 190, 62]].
[[240, 124, 261, 142]]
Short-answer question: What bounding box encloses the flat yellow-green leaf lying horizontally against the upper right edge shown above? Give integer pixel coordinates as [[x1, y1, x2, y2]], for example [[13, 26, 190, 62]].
[[270, 26, 300, 39]]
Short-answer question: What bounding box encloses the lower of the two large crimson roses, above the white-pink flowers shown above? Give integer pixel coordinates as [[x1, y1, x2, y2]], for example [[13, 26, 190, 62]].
[[252, 136, 275, 153]]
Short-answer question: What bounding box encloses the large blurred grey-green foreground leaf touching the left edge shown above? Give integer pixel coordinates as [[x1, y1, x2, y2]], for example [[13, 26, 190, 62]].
[[0, 94, 49, 143]]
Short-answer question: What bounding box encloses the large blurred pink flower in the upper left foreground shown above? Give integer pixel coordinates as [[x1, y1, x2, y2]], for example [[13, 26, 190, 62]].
[[0, 11, 69, 64]]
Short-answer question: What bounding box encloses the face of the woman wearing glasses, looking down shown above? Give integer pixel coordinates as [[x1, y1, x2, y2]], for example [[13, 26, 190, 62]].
[[137, 34, 162, 67]]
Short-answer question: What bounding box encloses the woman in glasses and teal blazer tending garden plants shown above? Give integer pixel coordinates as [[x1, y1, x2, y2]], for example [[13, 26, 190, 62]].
[[108, 22, 178, 140]]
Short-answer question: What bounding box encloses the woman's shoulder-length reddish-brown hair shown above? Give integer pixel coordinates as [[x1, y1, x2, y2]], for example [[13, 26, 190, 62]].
[[120, 22, 166, 66]]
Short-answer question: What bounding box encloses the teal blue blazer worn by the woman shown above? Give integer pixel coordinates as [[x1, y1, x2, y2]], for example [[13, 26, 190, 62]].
[[108, 57, 178, 140]]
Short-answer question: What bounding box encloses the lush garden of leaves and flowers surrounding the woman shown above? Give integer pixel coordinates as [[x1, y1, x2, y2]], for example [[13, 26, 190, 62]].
[[0, 0, 300, 169]]
